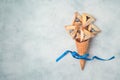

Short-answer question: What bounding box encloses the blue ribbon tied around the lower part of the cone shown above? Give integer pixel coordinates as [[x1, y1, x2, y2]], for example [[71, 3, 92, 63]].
[[56, 50, 115, 62]]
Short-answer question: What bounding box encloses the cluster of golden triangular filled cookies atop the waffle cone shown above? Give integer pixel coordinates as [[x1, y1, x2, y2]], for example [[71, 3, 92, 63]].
[[65, 12, 100, 41]]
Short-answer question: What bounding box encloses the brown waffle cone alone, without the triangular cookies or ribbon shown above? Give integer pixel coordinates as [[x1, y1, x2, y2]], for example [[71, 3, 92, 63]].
[[76, 40, 89, 70]]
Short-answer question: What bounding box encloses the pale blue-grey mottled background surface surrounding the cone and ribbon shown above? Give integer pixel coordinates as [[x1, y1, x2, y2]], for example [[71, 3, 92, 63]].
[[0, 0, 120, 80]]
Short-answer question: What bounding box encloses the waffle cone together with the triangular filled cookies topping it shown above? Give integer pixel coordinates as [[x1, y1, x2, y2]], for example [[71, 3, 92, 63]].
[[65, 12, 100, 70]]
